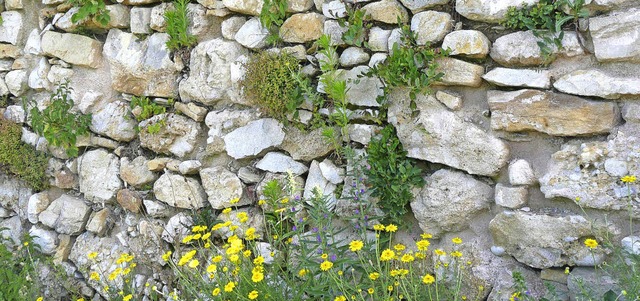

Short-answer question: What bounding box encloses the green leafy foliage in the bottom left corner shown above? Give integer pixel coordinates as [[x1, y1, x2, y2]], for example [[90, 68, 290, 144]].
[[0, 233, 41, 301]]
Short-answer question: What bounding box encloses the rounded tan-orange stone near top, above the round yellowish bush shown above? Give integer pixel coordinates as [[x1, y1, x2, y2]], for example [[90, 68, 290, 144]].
[[280, 13, 325, 43]]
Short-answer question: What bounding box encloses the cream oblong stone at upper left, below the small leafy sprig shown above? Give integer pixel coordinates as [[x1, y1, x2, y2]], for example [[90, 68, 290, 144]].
[[41, 31, 102, 68]]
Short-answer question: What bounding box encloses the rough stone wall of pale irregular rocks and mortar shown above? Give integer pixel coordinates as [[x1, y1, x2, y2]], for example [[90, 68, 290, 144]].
[[0, 0, 640, 300]]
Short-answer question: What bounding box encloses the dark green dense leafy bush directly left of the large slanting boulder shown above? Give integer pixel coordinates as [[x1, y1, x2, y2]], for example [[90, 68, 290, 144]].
[[366, 125, 424, 223]]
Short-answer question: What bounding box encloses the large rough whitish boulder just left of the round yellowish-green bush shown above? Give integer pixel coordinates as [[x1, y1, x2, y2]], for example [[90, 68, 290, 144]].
[[180, 39, 248, 105]]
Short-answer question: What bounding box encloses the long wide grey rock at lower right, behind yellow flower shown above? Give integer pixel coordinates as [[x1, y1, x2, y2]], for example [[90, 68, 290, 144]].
[[489, 211, 603, 269]]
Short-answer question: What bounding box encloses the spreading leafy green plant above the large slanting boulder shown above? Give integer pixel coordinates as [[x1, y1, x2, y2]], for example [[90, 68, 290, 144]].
[[366, 20, 448, 105]]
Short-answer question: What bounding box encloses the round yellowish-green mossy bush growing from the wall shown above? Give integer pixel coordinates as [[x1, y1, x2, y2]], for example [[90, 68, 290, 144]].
[[243, 52, 311, 123]]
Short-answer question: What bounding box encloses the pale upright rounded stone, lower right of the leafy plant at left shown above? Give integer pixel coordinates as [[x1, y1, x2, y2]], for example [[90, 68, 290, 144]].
[[78, 149, 122, 203]]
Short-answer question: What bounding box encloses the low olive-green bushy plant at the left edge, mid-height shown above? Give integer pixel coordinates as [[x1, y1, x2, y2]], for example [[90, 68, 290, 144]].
[[0, 119, 49, 191]]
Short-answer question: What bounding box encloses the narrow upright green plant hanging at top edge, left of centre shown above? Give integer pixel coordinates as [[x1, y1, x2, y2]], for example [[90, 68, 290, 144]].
[[164, 0, 198, 50]]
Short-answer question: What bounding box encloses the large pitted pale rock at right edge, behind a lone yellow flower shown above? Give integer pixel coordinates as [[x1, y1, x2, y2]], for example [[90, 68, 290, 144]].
[[540, 127, 640, 217]]
